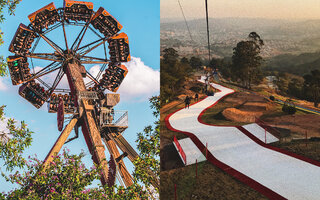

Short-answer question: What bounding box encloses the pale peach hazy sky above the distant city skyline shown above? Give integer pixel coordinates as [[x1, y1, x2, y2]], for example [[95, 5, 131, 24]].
[[160, 0, 320, 20]]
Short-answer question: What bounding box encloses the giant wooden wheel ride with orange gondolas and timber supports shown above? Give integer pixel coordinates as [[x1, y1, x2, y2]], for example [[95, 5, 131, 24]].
[[7, 0, 159, 188]]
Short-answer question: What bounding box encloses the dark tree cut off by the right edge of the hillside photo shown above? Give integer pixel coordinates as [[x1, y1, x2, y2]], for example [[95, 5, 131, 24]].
[[303, 70, 320, 107]]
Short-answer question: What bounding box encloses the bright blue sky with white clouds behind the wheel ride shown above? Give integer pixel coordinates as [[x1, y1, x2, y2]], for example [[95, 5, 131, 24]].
[[0, 0, 160, 192]]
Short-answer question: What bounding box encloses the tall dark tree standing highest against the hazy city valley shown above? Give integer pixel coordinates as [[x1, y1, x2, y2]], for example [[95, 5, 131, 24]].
[[232, 32, 264, 89]]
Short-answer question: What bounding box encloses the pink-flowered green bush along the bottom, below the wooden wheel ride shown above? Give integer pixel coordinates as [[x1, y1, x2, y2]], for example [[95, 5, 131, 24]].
[[0, 149, 147, 200]]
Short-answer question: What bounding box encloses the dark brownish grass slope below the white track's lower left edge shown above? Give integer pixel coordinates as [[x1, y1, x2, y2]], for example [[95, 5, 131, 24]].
[[160, 161, 267, 200]]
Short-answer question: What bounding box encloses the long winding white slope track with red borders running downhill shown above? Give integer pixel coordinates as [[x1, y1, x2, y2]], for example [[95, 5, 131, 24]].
[[166, 77, 320, 200]]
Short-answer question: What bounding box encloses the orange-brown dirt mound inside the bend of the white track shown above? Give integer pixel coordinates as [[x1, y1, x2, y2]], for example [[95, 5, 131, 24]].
[[222, 108, 263, 123]]
